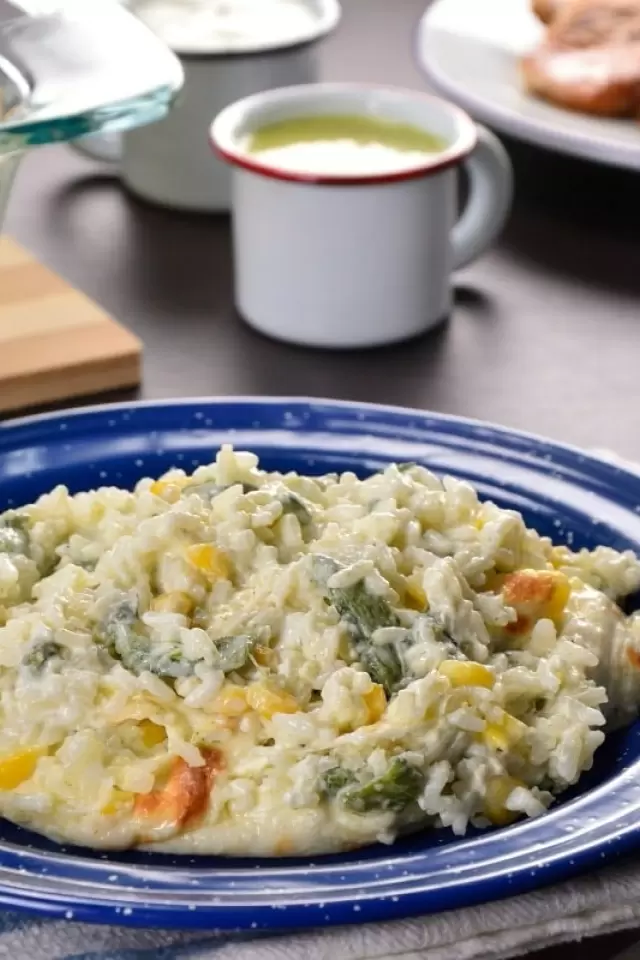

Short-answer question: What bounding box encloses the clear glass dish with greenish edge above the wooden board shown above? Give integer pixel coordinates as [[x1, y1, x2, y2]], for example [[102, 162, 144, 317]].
[[0, 0, 183, 227]]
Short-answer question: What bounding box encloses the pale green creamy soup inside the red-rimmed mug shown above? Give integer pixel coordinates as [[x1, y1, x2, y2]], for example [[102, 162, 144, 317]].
[[245, 114, 447, 176]]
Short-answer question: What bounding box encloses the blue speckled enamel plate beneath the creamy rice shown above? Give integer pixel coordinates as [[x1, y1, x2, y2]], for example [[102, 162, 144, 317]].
[[0, 399, 640, 931]]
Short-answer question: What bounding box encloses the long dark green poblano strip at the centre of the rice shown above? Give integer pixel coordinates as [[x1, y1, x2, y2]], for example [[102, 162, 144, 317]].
[[313, 554, 404, 695]]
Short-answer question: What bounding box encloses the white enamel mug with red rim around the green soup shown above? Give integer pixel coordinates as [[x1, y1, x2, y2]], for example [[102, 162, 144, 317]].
[[211, 84, 513, 349]]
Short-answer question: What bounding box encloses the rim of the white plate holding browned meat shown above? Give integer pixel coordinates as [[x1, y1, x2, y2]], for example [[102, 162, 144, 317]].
[[412, 0, 640, 171]]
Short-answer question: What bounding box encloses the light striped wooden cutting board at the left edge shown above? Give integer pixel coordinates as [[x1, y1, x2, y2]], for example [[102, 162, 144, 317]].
[[0, 237, 142, 413]]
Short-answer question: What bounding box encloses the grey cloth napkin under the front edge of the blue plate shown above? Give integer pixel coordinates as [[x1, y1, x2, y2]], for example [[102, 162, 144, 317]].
[[0, 863, 640, 960]]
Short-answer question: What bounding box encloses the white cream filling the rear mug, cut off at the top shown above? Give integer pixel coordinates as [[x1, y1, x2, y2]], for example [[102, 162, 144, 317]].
[[129, 0, 319, 53]]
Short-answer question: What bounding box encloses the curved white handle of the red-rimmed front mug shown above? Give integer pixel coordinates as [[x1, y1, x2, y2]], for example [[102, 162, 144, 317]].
[[451, 126, 513, 270]]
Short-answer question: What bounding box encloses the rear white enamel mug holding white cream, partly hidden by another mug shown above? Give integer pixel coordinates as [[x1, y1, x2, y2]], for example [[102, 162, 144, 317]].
[[77, 0, 341, 213]]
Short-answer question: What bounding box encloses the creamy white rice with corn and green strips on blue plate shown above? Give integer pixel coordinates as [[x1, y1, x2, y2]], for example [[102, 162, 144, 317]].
[[0, 448, 640, 855]]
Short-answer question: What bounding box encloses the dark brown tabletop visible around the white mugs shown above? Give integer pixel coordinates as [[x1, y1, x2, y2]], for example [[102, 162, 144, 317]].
[[6, 0, 640, 960]]
